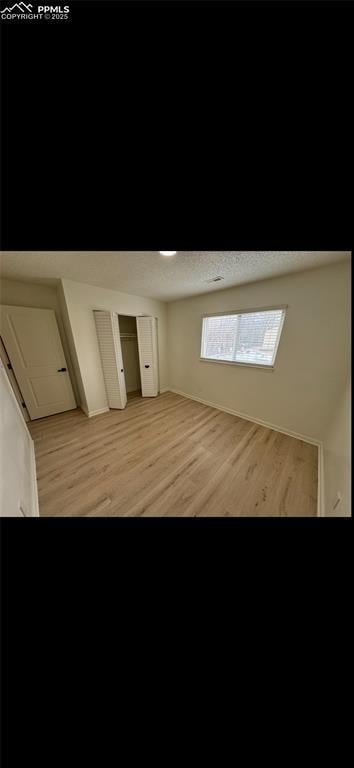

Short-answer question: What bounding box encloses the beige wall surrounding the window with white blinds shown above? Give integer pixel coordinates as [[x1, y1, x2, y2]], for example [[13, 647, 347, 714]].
[[168, 262, 350, 440]]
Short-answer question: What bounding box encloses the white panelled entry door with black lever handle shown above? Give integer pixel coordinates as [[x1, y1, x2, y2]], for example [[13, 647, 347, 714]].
[[0, 306, 77, 419]]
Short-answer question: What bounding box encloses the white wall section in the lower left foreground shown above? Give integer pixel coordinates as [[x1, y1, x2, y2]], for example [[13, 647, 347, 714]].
[[0, 360, 39, 517]]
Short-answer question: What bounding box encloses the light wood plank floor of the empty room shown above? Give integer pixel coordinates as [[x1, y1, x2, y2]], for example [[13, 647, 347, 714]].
[[28, 392, 318, 517]]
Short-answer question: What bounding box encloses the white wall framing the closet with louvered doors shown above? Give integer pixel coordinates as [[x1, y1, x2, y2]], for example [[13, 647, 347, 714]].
[[61, 280, 168, 413]]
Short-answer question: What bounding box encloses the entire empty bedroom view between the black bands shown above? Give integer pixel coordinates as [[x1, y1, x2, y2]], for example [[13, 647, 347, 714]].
[[0, 251, 351, 517]]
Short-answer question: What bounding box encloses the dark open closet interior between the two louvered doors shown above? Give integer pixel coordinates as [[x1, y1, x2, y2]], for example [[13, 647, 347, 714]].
[[118, 315, 141, 400]]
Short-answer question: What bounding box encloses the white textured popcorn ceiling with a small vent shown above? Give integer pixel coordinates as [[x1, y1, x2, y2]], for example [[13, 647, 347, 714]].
[[0, 251, 350, 301]]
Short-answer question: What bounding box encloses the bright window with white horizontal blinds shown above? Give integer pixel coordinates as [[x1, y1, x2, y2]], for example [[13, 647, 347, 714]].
[[201, 307, 285, 368]]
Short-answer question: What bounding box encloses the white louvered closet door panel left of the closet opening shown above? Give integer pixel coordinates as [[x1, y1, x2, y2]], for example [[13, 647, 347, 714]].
[[93, 310, 127, 408]]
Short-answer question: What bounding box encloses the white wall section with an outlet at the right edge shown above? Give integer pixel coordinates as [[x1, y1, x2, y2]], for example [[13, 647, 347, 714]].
[[323, 376, 351, 517]]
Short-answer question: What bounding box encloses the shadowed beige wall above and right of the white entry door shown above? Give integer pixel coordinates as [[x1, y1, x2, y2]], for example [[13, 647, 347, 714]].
[[0, 279, 80, 402]]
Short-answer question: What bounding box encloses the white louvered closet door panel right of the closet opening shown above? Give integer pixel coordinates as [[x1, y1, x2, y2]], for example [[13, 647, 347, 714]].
[[136, 317, 159, 397]]
